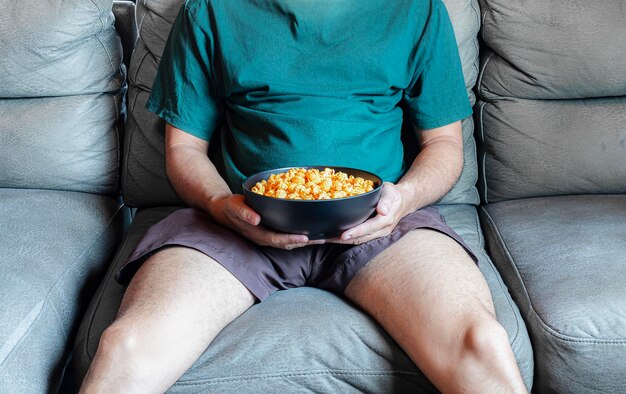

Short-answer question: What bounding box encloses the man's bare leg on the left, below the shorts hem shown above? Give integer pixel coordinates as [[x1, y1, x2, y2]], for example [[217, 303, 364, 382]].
[[81, 247, 255, 393]]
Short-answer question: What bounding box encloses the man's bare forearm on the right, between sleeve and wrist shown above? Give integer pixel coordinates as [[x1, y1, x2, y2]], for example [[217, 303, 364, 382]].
[[398, 122, 463, 213]]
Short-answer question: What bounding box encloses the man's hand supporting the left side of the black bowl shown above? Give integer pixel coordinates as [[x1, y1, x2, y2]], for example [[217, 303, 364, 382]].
[[211, 194, 324, 250]]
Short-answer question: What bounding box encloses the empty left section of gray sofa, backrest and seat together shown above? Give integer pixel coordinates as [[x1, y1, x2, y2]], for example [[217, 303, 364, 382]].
[[0, 0, 129, 393]]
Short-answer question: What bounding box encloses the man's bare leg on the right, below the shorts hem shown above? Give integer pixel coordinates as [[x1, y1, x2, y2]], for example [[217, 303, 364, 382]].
[[345, 229, 526, 393]]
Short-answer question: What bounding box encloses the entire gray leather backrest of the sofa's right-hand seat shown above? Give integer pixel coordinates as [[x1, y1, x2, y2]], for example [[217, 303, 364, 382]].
[[475, 0, 626, 202]]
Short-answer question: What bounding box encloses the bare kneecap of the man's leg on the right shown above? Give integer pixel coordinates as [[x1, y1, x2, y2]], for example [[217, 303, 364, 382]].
[[462, 317, 511, 362]]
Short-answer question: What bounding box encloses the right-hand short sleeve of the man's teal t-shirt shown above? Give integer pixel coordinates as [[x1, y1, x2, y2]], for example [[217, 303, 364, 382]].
[[404, 0, 472, 130]]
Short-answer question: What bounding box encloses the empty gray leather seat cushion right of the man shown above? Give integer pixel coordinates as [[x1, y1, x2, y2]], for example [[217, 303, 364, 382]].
[[481, 195, 626, 393]]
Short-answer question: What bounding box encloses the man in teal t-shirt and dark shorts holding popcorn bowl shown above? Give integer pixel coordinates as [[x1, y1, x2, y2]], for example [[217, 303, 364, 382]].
[[82, 0, 525, 393]]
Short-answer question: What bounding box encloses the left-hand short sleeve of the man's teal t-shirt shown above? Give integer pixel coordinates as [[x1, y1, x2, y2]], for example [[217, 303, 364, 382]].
[[146, 3, 221, 141]]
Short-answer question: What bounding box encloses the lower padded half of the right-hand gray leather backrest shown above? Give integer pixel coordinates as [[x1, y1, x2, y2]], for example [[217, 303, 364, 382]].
[[476, 97, 626, 202]]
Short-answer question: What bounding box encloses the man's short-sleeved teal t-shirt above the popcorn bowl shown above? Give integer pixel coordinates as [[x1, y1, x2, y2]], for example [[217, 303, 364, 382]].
[[147, 0, 472, 192]]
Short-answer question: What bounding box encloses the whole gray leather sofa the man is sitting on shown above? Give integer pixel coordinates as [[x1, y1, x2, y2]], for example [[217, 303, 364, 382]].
[[0, 0, 626, 393]]
